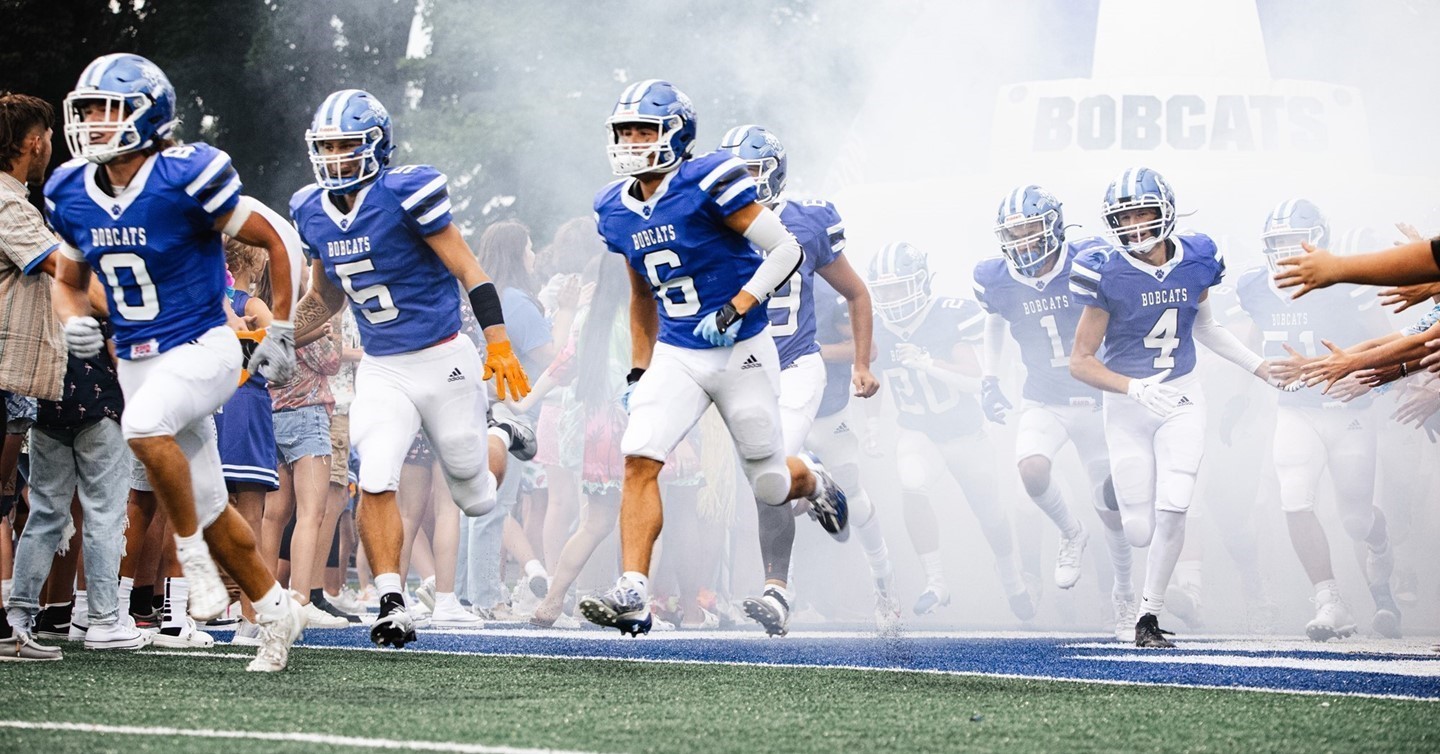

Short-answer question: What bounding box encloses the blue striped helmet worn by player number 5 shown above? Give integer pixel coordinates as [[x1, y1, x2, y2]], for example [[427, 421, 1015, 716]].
[[305, 89, 395, 194]]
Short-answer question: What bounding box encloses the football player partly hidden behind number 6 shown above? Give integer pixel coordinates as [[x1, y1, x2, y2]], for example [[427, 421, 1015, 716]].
[[720, 125, 893, 636]]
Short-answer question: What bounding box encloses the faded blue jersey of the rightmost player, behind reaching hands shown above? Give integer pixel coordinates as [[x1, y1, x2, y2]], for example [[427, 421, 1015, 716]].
[[1237, 266, 1390, 409]]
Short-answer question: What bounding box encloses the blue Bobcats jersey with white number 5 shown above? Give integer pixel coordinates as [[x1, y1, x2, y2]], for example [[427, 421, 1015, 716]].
[[289, 165, 461, 355]]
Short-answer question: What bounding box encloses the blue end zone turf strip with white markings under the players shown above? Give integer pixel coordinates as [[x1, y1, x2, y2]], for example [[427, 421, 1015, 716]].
[[216, 629, 1440, 701]]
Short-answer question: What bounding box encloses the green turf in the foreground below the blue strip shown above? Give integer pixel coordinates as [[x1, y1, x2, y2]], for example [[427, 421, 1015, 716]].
[[0, 649, 1440, 754]]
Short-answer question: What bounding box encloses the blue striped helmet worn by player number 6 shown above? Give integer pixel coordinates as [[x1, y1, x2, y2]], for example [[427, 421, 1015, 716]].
[[605, 79, 696, 176]]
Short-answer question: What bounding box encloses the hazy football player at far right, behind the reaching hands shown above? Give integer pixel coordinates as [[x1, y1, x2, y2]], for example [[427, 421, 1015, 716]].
[[1238, 199, 1400, 642]]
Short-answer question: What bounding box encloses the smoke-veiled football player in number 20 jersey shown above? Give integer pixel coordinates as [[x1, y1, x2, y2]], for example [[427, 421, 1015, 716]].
[[870, 242, 1040, 620]]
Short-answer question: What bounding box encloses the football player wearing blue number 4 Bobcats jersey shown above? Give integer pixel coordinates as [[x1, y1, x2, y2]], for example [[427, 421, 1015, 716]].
[[1070, 167, 1296, 648]]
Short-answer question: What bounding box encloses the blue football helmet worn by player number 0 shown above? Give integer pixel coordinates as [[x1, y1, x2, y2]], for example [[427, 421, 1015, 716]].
[[63, 52, 177, 164]]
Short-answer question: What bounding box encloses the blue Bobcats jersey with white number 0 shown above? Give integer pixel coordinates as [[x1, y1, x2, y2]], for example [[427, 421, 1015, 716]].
[[45, 142, 240, 358]]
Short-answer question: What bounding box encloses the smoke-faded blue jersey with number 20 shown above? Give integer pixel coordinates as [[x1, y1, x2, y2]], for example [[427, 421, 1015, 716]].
[[876, 296, 985, 440]]
